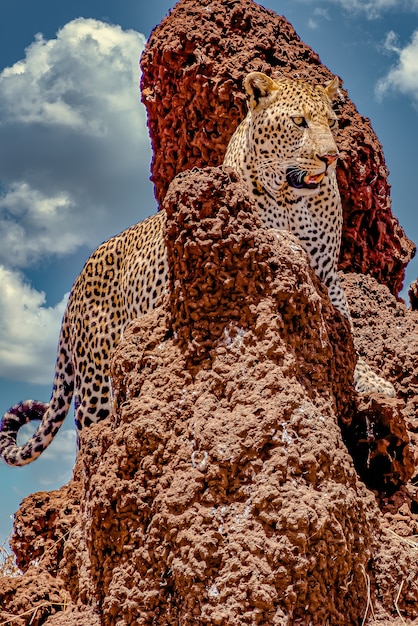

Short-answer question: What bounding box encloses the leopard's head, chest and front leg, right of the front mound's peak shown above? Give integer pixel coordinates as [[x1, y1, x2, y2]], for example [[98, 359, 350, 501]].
[[223, 72, 396, 398]]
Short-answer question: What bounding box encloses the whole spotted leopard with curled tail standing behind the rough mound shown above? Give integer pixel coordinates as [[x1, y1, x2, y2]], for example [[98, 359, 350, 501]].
[[0, 72, 395, 466]]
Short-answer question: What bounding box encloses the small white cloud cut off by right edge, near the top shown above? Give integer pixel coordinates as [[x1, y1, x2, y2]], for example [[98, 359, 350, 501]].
[[376, 30, 418, 107]]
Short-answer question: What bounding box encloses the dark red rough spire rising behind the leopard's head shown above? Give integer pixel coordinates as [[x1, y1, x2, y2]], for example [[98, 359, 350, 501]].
[[141, 0, 415, 295]]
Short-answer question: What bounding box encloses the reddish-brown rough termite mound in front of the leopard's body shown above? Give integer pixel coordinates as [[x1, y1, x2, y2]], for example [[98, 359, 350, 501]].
[[0, 169, 418, 626]]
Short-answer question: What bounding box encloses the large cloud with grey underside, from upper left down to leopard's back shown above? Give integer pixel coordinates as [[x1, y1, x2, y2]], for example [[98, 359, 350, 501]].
[[0, 18, 154, 267]]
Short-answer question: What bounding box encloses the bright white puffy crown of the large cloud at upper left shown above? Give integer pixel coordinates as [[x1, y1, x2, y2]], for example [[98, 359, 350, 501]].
[[0, 18, 145, 134]]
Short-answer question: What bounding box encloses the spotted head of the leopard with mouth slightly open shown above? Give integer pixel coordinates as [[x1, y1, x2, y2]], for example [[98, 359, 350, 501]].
[[244, 72, 339, 197]]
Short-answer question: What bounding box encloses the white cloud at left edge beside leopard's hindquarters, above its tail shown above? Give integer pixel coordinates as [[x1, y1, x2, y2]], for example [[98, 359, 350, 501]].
[[0, 265, 68, 384]]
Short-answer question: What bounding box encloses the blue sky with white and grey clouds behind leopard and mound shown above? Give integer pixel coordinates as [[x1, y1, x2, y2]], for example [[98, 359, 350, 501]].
[[0, 0, 418, 546]]
